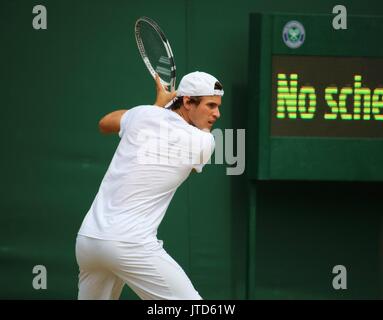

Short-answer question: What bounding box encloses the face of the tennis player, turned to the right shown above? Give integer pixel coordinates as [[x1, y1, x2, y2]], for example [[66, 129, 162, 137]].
[[189, 96, 222, 131]]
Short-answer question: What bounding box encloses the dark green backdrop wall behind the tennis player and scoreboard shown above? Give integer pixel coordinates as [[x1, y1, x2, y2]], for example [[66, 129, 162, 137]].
[[0, 0, 383, 299]]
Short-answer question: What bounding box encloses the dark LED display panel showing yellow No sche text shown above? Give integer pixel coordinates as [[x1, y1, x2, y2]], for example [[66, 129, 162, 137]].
[[271, 56, 383, 138]]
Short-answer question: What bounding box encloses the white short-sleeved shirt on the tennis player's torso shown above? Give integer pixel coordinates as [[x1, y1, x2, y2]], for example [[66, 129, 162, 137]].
[[79, 105, 215, 243]]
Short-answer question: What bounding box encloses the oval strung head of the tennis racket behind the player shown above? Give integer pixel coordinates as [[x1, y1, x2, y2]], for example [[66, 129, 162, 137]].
[[134, 17, 176, 90]]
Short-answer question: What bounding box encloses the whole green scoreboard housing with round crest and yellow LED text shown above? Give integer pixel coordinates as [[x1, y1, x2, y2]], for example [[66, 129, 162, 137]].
[[246, 14, 383, 181]]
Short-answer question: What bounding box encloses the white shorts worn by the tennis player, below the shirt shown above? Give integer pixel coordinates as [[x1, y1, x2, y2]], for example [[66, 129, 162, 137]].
[[76, 235, 202, 300]]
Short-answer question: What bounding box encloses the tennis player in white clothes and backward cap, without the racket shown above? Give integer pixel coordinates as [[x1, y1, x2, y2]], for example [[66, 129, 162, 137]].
[[76, 72, 224, 300]]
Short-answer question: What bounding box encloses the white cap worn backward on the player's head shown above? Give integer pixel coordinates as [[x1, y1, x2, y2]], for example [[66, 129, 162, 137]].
[[177, 71, 224, 97]]
